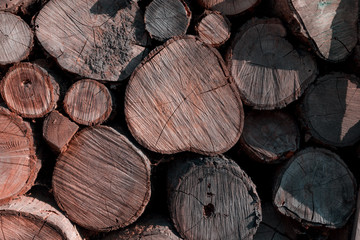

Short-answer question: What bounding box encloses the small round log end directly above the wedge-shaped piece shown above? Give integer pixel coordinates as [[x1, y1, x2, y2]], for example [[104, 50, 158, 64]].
[[64, 80, 112, 125]]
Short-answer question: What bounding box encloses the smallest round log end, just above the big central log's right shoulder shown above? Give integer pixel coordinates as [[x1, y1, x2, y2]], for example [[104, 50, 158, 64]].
[[196, 11, 231, 47]]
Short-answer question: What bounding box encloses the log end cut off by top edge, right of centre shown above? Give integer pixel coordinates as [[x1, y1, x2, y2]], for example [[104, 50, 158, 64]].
[[197, 0, 260, 15]]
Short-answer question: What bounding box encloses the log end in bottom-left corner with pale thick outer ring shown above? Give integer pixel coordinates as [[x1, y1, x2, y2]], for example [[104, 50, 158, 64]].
[[0, 196, 82, 240]]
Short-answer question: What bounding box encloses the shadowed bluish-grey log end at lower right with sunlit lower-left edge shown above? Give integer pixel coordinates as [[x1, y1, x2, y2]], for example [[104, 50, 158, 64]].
[[274, 148, 357, 228]]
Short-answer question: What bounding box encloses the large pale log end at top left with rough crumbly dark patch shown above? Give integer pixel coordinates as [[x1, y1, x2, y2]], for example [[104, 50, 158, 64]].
[[35, 0, 148, 81]]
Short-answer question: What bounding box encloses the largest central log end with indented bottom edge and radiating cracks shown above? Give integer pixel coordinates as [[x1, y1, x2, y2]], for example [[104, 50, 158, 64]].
[[125, 36, 244, 155]]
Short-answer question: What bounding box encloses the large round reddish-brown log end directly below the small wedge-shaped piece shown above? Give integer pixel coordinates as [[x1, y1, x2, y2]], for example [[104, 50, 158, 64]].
[[53, 126, 151, 231]]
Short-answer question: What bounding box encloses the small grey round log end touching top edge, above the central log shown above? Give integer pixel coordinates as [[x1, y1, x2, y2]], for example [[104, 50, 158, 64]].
[[145, 0, 191, 41]]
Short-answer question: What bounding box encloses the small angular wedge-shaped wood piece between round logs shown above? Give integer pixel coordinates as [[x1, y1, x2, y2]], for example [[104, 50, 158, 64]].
[[43, 111, 79, 153]]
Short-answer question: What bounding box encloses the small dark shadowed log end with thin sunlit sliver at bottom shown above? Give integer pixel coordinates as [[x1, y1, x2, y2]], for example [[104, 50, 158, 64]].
[[240, 111, 300, 163]]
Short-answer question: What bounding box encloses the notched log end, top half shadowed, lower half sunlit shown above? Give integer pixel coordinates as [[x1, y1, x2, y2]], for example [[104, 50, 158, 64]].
[[227, 18, 318, 109]]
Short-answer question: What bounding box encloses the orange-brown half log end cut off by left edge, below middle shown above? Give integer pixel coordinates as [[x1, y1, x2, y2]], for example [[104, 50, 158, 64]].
[[0, 107, 41, 205]]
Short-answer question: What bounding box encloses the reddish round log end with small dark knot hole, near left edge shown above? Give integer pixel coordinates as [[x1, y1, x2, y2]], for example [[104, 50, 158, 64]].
[[1, 63, 59, 118]]
